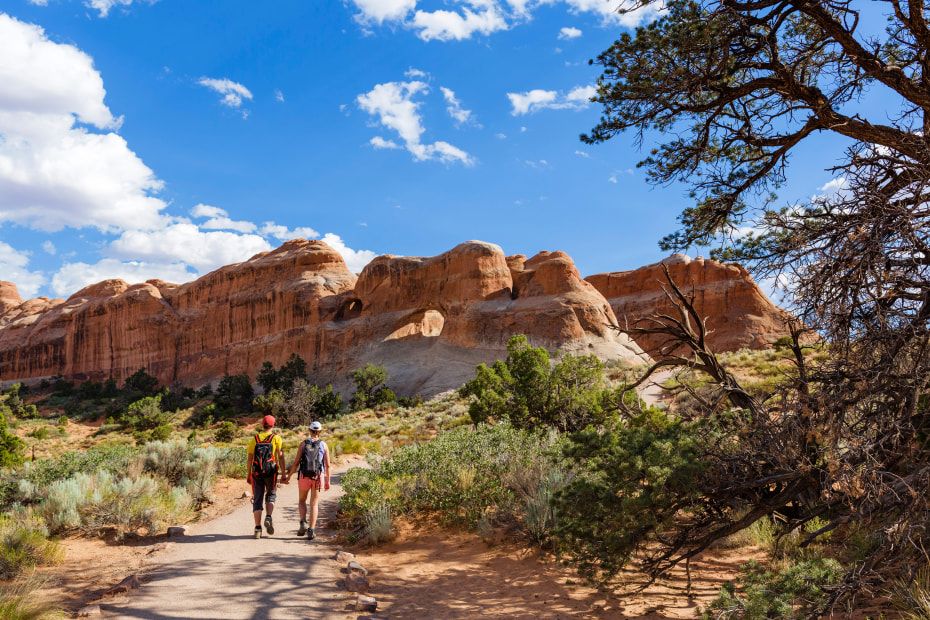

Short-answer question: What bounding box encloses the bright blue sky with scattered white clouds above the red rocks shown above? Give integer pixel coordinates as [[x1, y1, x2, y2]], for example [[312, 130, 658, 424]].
[[0, 0, 839, 298]]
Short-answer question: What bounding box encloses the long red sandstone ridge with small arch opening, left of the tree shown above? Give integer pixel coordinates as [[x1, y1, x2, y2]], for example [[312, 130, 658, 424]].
[[0, 239, 648, 395]]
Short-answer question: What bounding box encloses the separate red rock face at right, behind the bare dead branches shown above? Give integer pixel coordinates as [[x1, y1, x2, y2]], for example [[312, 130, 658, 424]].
[[585, 254, 788, 352]]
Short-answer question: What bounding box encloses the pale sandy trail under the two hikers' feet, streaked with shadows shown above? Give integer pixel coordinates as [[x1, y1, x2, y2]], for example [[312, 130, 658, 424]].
[[100, 463, 365, 620]]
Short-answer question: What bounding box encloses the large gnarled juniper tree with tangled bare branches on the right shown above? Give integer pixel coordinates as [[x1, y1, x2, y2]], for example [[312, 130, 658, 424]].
[[582, 0, 930, 605]]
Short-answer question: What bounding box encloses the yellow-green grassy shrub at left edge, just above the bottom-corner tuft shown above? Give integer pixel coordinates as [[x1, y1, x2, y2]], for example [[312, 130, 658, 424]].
[[0, 513, 64, 580]]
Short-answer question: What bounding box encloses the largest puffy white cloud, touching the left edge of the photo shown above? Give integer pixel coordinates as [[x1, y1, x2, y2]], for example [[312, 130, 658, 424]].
[[0, 13, 166, 232]]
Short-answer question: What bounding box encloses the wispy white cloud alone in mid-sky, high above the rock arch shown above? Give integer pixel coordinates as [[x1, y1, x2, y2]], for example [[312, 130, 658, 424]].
[[356, 80, 474, 166]]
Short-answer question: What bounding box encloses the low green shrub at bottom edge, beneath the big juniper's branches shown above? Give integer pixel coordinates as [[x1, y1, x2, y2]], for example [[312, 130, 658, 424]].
[[701, 558, 844, 620]]
